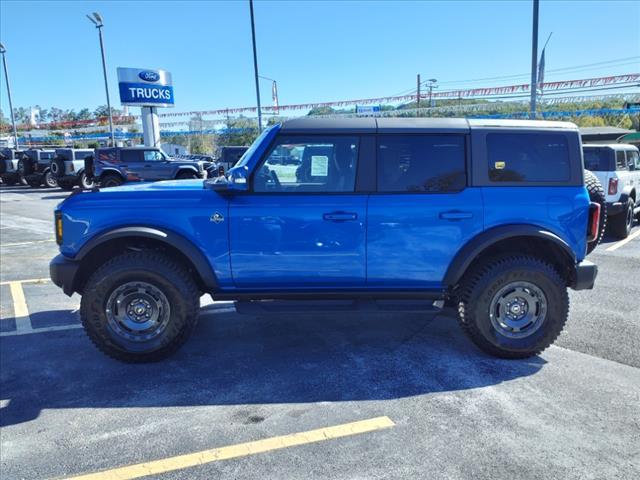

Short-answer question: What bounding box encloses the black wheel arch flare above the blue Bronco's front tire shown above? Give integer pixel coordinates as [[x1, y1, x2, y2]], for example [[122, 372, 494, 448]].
[[73, 225, 217, 293]]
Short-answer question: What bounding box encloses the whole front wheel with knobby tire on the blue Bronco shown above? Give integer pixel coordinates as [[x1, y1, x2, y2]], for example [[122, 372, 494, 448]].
[[80, 251, 200, 363]]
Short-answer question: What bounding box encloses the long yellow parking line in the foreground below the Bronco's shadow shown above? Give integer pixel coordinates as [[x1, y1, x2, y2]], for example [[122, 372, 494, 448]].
[[65, 417, 395, 480]]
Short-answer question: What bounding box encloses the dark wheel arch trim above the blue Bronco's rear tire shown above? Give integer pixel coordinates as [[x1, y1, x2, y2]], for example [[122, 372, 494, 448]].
[[443, 225, 576, 287]]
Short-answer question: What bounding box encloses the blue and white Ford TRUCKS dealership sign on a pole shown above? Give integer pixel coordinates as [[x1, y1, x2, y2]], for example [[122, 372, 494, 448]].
[[118, 67, 174, 107]]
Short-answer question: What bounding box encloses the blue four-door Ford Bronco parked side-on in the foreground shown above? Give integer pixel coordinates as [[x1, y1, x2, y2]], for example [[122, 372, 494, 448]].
[[50, 118, 600, 362]]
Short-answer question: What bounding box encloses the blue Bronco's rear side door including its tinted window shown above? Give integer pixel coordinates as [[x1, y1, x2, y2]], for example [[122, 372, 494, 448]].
[[367, 133, 483, 288]]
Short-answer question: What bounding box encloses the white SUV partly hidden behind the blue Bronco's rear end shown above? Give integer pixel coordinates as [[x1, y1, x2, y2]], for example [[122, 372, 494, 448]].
[[583, 143, 640, 238]]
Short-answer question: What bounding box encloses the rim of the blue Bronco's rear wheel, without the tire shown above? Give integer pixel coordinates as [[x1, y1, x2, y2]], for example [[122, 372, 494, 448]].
[[489, 282, 547, 338]]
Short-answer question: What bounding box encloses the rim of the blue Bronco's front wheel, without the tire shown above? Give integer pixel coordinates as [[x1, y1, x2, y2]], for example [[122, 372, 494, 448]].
[[105, 282, 171, 342]]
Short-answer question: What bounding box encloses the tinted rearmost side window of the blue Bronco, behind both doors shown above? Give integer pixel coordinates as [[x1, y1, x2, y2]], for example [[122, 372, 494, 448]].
[[487, 133, 571, 183]]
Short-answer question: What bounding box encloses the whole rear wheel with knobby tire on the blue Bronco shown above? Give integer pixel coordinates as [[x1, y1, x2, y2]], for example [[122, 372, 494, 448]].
[[458, 255, 569, 358]]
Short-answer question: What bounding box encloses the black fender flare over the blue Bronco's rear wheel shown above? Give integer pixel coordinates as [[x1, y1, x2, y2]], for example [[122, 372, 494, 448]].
[[443, 224, 576, 287]]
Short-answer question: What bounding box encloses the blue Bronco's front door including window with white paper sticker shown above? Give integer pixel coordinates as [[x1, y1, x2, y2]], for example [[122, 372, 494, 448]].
[[229, 135, 367, 291]]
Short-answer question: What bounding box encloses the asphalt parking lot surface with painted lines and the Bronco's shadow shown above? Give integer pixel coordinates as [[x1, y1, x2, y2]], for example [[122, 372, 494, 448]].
[[0, 187, 640, 480]]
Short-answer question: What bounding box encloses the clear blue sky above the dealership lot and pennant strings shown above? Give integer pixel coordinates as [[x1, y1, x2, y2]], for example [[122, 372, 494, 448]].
[[0, 0, 640, 116]]
